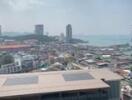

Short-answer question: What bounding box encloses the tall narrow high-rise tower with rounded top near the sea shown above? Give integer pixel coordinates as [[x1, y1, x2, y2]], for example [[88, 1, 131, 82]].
[[66, 24, 72, 43]]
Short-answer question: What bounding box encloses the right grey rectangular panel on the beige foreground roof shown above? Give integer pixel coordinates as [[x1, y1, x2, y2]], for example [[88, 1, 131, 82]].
[[63, 73, 94, 81]]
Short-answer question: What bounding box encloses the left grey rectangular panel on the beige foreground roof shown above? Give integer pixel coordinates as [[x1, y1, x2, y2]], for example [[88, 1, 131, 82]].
[[4, 76, 38, 86]]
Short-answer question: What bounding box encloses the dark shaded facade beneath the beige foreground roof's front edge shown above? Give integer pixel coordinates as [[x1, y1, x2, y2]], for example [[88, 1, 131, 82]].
[[3, 89, 109, 100]]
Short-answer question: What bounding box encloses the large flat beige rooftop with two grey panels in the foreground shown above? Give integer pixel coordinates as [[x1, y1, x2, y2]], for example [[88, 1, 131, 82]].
[[0, 69, 122, 97]]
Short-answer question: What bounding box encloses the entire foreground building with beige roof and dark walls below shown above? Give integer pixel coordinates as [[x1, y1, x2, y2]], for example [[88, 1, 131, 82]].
[[0, 69, 122, 100]]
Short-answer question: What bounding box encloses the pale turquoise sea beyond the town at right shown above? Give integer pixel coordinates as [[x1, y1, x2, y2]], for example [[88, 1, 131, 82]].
[[74, 35, 132, 46]]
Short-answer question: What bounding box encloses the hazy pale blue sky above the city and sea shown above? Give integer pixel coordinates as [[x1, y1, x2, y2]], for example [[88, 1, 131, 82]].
[[0, 0, 132, 36]]
